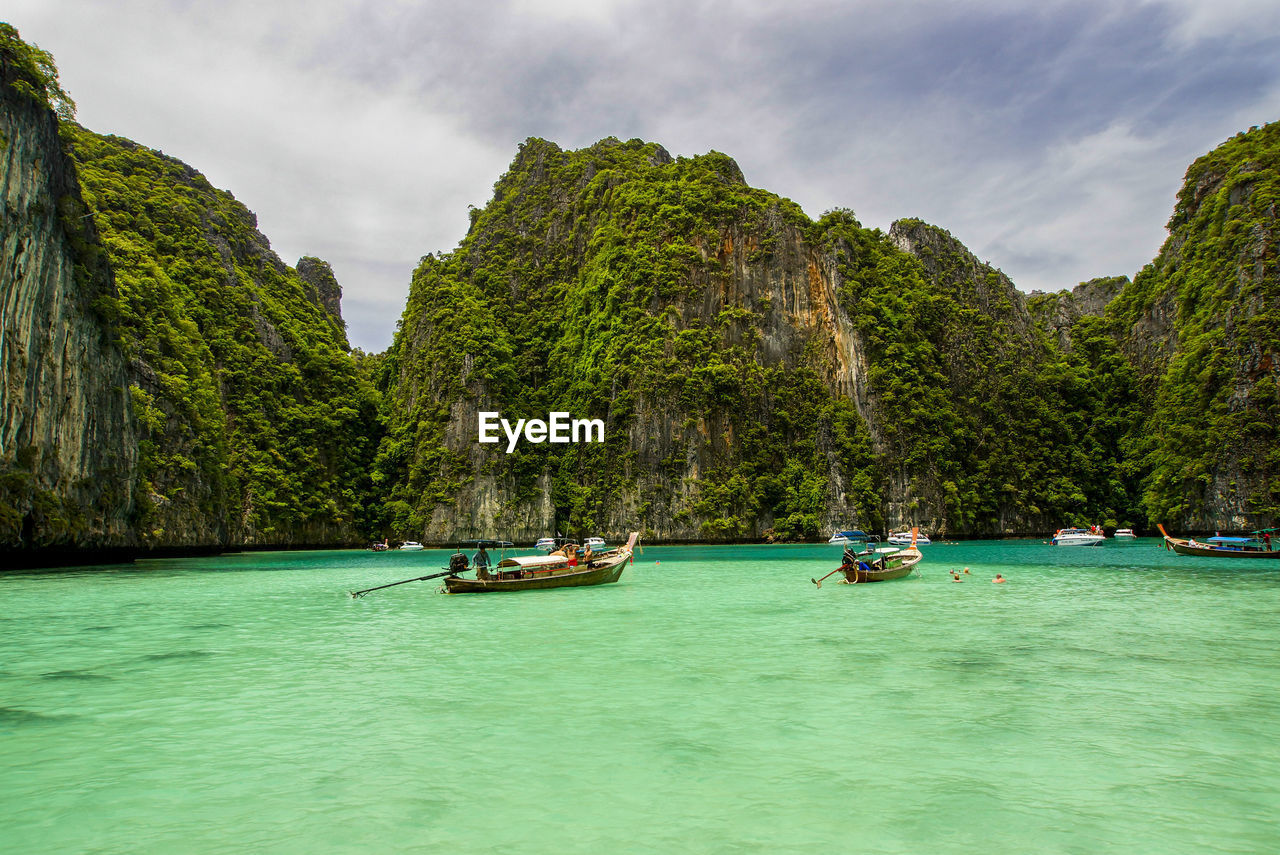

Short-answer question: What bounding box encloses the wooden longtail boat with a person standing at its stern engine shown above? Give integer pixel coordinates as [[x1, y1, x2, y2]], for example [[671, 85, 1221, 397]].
[[443, 531, 640, 594]]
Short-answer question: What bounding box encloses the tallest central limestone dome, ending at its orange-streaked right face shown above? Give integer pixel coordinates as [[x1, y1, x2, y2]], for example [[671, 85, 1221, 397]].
[[373, 140, 878, 541]]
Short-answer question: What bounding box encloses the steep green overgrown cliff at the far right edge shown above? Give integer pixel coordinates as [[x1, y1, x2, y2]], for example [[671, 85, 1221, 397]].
[[1111, 123, 1280, 525]]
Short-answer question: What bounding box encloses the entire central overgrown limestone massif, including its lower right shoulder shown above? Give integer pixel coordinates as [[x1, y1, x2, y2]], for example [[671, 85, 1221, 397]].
[[380, 140, 1141, 541]]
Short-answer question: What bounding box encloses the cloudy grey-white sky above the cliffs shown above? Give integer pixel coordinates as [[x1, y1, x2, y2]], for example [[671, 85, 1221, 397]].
[[10, 0, 1280, 351]]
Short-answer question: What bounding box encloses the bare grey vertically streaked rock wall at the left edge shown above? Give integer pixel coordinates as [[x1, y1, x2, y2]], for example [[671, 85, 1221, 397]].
[[0, 54, 137, 561]]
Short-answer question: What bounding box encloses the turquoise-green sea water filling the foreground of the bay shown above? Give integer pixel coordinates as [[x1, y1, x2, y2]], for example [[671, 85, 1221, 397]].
[[0, 540, 1280, 854]]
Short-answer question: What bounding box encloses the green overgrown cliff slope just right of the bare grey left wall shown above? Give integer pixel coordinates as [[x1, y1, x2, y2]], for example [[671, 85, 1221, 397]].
[[72, 127, 379, 545]]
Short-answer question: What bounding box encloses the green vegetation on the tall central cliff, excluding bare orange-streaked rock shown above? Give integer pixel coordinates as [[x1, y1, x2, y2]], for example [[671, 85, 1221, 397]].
[[381, 140, 876, 538]]
